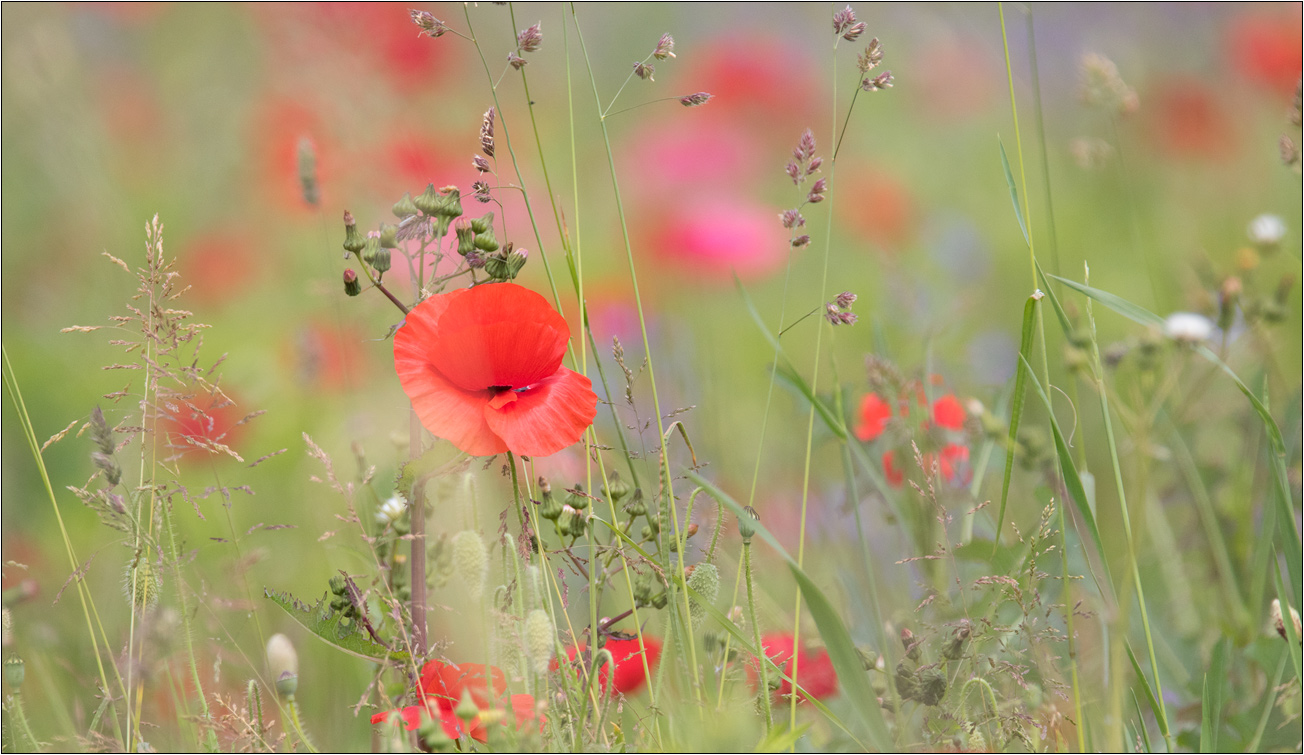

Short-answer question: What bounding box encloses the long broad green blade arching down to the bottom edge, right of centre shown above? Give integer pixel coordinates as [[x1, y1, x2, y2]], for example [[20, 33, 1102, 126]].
[[686, 469, 893, 751]]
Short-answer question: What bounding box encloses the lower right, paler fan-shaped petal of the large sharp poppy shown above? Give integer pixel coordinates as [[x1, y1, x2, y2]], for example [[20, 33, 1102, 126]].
[[484, 368, 597, 456]]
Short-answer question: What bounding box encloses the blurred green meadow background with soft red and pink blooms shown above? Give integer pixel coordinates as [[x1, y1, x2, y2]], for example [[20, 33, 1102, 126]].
[[0, 3, 1301, 750]]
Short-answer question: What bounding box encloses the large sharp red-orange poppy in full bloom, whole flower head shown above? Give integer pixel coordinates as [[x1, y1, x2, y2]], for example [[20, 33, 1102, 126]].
[[394, 283, 597, 456]]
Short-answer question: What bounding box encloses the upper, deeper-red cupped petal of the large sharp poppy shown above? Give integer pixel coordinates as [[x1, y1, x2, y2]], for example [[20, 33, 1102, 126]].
[[417, 283, 570, 391]]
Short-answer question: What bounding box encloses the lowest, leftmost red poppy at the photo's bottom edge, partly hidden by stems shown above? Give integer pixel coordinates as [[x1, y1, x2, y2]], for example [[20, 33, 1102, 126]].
[[372, 660, 544, 742]]
